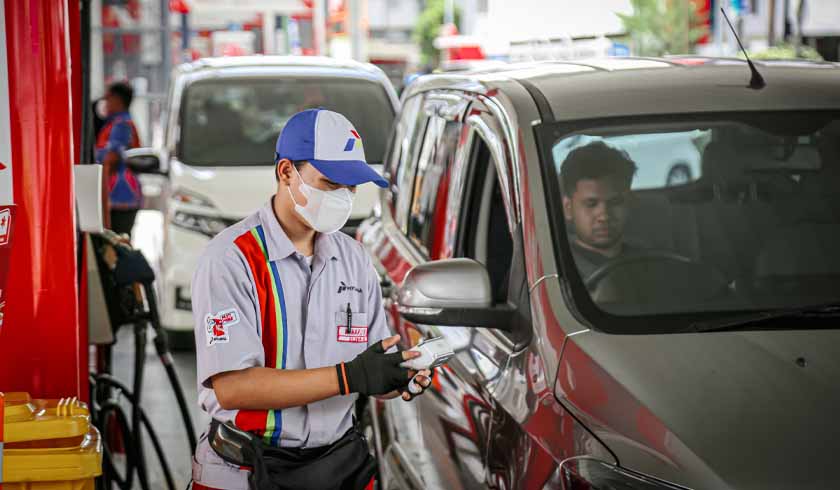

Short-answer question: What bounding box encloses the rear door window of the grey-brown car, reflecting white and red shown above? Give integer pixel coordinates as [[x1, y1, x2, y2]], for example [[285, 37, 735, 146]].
[[408, 117, 462, 259]]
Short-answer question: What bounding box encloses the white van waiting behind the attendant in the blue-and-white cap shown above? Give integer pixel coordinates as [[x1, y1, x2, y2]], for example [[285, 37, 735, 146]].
[[129, 56, 399, 345]]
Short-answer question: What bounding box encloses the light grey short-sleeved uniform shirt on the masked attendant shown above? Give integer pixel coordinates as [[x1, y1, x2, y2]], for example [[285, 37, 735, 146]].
[[192, 201, 390, 488]]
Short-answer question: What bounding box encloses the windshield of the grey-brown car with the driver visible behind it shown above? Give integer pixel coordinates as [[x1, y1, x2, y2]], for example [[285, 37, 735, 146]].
[[544, 112, 840, 324]]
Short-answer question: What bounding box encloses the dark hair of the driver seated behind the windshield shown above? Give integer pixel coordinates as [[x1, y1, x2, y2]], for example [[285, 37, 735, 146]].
[[560, 141, 636, 196]]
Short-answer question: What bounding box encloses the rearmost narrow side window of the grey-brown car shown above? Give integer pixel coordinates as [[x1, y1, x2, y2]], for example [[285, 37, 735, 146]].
[[391, 97, 429, 233]]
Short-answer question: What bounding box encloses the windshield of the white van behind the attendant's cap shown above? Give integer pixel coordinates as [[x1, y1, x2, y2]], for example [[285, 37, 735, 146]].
[[178, 77, 394, 166]]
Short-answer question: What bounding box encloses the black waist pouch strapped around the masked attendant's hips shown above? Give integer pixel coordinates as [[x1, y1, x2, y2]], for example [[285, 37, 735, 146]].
[[210, 421, 376, 490]]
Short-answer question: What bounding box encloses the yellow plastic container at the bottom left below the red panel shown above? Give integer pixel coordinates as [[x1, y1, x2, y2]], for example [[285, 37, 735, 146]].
[[0, 393, 102, 490]]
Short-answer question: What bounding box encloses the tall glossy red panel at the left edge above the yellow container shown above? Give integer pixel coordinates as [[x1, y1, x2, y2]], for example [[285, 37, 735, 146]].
[[0, 0, 82, 398]]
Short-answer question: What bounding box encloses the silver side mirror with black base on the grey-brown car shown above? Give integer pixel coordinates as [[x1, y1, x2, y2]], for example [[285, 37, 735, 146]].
[[397, 259, 515, 331]]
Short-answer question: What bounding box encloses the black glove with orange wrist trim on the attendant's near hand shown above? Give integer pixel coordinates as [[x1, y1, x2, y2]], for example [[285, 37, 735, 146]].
[[335, 342, 409, 396]]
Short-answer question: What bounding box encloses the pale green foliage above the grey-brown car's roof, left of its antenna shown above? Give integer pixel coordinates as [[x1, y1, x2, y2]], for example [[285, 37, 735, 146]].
[[616, 0, 708, 56]]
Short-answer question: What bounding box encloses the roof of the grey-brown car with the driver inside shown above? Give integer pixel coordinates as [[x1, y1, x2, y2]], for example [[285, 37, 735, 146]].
[[406, 56, 840, 121]]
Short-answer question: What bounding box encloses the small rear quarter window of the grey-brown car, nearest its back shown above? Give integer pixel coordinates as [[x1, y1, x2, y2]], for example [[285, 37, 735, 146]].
[[388, 95, 428, 218]]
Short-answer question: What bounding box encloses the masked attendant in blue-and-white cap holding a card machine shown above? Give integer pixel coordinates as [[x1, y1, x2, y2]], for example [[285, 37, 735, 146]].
[[192, 109, 431, 490]]
